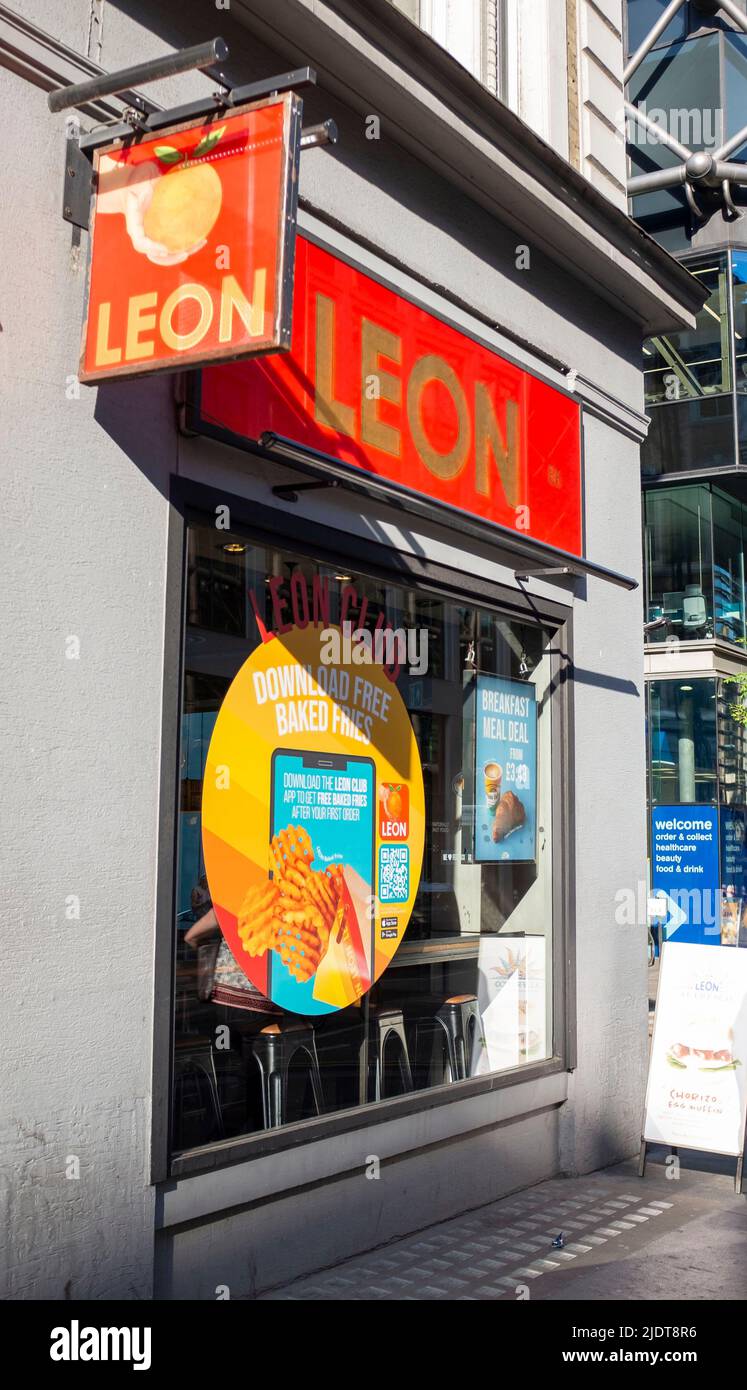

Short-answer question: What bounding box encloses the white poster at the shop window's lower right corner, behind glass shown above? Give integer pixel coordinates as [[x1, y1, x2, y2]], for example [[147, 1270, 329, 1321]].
[[472, 934, 547, 1076]]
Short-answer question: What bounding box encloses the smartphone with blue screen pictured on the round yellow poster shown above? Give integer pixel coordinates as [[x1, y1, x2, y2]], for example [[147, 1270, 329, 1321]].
[[267, 748, 376, 1015]]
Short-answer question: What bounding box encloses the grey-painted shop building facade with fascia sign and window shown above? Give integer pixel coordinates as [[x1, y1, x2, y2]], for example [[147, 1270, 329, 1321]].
[[0, 0, 698, 1298]]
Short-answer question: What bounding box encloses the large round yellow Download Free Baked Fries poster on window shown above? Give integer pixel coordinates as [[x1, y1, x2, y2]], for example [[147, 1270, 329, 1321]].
[[202, 626, 426, 1015]]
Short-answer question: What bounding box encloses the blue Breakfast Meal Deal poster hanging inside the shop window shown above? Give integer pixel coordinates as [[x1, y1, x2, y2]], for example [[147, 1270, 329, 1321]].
[[474, 676, 537, 863]]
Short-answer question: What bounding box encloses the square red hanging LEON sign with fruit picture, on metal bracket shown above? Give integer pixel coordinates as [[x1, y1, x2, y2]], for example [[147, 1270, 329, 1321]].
[[79, 93, 300, 382]]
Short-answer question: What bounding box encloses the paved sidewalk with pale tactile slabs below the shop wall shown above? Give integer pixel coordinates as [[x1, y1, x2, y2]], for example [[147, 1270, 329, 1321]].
[[262, 1150, 747, 1301]]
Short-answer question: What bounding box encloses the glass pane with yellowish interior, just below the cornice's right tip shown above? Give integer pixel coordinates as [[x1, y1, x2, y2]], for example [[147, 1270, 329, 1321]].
[[644, 256, 732, 406]]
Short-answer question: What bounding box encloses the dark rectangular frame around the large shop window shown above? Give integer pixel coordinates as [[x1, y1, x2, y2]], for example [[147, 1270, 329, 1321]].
[[152, 477, 576, 1184]]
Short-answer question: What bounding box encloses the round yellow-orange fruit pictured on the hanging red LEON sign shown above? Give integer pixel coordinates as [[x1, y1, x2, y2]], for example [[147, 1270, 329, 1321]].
[[143, 164, 223, 252]]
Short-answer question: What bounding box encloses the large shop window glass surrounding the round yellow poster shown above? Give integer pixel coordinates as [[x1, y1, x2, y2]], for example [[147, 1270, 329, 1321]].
[[172, 518, 556, 1154]]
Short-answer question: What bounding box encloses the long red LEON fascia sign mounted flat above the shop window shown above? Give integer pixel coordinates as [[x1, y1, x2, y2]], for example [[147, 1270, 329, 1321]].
[[191, 236, 583, 556]]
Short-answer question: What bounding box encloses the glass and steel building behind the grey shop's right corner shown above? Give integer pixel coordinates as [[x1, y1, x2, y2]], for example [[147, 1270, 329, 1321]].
[[626, 0, 747, 944]]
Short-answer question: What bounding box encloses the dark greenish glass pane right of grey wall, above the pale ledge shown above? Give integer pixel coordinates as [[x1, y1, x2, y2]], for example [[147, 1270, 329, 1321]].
[[644, 487, 714, 641]]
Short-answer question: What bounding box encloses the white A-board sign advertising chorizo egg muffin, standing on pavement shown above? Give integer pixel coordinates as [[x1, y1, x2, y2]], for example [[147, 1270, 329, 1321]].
[[643, 941, 747, 1155]]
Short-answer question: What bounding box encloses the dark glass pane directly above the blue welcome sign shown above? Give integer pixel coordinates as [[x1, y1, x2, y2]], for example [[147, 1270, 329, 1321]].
[[648, 678, 716, 806]]
